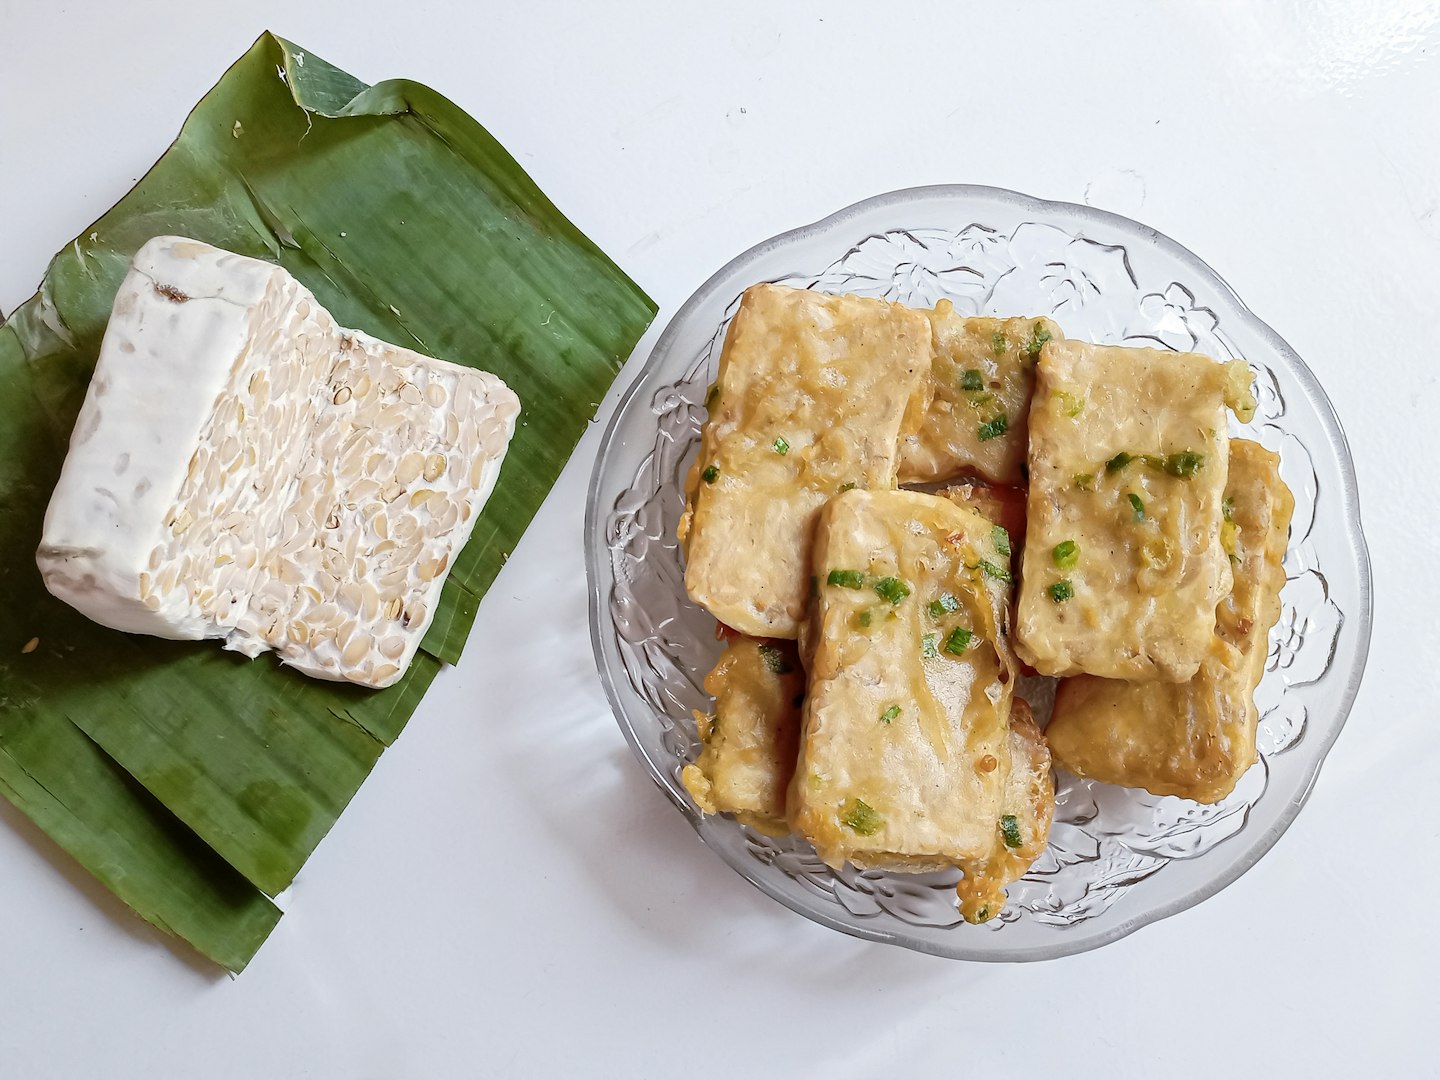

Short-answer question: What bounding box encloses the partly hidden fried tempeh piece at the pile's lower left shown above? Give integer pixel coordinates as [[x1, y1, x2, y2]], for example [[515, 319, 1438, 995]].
[[680, 636, 805, 837]]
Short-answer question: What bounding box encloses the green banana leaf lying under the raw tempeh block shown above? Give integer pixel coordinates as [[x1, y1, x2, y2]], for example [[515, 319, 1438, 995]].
[[0, 35, 655, 969]]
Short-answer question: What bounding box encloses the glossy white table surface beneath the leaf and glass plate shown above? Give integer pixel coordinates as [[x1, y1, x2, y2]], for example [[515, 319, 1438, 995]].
[[0, 0, 1440, 1080]]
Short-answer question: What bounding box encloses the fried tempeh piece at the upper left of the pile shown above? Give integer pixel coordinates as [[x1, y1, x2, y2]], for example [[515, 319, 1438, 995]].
[[678, 285, 930, 638]]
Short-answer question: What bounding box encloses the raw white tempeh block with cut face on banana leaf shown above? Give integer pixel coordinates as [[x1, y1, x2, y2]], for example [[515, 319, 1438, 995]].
[[37, 236, 520, 687]]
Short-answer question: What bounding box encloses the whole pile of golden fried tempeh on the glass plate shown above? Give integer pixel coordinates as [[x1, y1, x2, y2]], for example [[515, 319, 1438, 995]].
[[680, 285, 1290, 922]]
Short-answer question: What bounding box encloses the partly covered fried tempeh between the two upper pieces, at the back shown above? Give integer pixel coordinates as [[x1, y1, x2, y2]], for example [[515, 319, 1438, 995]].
[[900, 300, 1064, 484]]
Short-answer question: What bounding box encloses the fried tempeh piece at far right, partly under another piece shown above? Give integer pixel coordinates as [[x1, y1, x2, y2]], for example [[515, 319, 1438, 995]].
[[1045, 439, 1295, 802]]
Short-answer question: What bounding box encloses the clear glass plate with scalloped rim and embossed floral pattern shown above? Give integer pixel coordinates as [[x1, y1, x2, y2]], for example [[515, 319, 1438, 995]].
[[585, 186, 1371, 960]]
